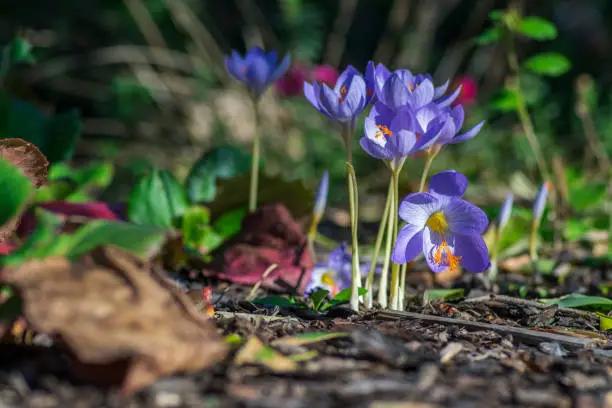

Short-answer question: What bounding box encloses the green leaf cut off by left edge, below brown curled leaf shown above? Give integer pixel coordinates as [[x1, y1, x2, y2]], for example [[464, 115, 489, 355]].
[[0, 158, 34, 225]]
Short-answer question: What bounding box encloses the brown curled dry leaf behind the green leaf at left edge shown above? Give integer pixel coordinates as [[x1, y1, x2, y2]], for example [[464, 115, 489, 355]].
[[0, 139, 49, 242]]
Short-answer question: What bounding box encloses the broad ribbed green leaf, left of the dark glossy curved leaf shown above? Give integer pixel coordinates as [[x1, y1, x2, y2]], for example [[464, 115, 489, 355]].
[[128, 170, 189, 228]]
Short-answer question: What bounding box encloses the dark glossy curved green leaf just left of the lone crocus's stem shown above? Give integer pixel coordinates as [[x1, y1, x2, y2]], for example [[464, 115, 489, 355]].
[[185, 146, 251, 203]]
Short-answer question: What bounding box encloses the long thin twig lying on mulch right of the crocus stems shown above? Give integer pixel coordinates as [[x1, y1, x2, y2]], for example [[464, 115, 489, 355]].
[[376, 310, 608, 349]]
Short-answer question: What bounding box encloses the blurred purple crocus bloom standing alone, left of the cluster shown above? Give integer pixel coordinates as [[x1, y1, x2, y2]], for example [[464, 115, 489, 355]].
[[225, 47, 291, 98]]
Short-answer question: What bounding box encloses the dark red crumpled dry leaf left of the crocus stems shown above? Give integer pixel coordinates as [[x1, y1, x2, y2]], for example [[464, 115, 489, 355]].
[[203, 204, 314, 291]]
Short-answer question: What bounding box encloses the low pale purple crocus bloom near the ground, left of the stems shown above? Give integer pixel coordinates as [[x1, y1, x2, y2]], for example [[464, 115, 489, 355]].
[[305, 242, 369, 296]]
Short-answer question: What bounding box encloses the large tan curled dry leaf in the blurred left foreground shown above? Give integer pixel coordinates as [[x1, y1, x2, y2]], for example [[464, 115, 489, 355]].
[[4, 248, 227, 394]]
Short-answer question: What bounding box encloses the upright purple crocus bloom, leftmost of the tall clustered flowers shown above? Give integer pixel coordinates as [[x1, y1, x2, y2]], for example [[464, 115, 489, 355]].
[[304, 65, 372, 127]]
